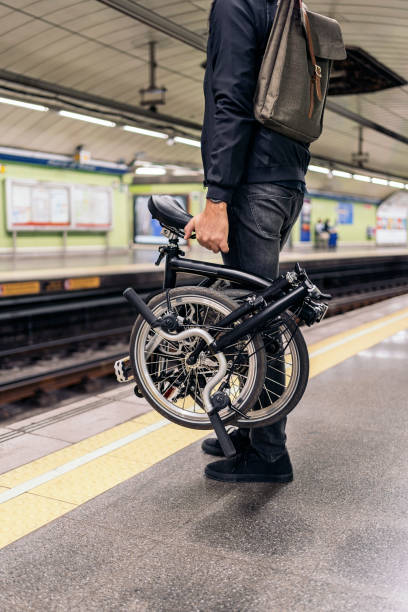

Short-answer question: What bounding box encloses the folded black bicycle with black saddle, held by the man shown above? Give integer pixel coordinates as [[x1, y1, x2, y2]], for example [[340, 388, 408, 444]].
[[115, 195, 331, 457]]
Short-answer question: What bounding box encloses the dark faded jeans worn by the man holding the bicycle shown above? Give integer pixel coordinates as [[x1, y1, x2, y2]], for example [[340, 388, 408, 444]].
[[223, 183, 303, 462]]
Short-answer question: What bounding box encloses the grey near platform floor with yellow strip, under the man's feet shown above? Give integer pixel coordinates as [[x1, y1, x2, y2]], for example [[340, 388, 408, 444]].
[[0, 295, 408, 612]]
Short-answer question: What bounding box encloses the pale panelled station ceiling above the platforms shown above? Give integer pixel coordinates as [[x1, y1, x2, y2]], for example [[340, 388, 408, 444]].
[[0, 0, 408, 195]]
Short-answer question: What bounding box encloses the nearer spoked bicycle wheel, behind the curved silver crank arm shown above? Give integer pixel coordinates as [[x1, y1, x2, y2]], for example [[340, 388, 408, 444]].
[[130, 287, 266, 429]]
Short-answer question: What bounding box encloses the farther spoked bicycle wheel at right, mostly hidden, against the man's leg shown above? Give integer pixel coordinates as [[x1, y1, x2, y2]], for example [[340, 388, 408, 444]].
[[236, 314, 309, 427]]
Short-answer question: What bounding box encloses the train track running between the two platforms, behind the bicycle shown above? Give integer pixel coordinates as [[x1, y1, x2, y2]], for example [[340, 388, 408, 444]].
[[0, 282, 408, 412]]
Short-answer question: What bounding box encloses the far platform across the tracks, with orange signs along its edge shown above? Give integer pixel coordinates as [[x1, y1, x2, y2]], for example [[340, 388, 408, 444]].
[[0, 245, 408, 307]]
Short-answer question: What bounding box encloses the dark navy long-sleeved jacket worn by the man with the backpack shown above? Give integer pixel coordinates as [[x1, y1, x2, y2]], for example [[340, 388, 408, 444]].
[[201, 0, 310, 203]]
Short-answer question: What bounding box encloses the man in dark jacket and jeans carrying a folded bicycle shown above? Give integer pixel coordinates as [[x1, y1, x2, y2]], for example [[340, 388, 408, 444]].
[[185, 0, 310, 482]]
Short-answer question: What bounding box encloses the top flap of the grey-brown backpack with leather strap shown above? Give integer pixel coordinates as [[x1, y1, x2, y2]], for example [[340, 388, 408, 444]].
[[307, 11, 347, 60]]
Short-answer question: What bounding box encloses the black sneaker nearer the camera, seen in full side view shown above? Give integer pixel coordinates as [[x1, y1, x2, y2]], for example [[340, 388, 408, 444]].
[[205, 448, 293, 482]]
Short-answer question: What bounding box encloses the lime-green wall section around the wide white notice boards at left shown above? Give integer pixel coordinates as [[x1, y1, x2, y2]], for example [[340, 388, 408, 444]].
[[0, 162, 129, 252]]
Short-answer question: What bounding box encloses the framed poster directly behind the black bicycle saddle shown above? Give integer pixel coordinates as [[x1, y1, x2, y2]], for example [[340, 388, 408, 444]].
[[133, 194, 188, 244]]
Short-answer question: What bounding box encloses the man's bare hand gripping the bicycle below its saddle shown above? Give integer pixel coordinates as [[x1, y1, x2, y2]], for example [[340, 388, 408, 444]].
[[184, 200, 229, 253]]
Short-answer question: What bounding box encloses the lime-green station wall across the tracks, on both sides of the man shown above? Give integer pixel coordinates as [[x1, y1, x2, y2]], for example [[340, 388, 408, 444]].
[[0, 162, 377, 252]]
